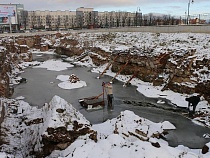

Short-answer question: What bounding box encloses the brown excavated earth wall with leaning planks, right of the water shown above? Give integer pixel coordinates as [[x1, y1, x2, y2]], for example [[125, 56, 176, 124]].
[[56, 32, 210, 102]]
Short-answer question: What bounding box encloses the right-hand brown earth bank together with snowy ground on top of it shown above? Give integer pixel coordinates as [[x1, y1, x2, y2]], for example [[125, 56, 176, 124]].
[[53, 33, 210, 103]]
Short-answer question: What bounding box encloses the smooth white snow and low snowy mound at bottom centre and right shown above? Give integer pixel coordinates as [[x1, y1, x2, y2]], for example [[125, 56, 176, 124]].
[[45, 96, 205, 158]]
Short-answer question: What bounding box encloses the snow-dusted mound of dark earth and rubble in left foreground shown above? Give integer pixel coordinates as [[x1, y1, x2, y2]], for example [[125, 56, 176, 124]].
[[1, 96, 97, 157]]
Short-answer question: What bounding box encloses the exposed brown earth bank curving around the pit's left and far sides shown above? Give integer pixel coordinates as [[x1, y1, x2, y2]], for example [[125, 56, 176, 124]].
[[0, 33, 210, 102]]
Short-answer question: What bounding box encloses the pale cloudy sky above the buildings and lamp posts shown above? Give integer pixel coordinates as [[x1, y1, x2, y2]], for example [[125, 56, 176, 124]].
[[0, 0, 210, 15]]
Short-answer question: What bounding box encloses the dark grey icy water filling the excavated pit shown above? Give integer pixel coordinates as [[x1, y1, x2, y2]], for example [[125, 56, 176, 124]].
[[12, 55, 210, 148]]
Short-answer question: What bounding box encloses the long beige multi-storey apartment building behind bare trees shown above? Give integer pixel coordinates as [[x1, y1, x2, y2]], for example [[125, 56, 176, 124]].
[[25, 7, 142, 30]]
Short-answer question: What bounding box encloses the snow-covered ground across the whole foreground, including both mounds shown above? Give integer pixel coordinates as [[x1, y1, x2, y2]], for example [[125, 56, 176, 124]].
[[0, 96, 210, 158]]
